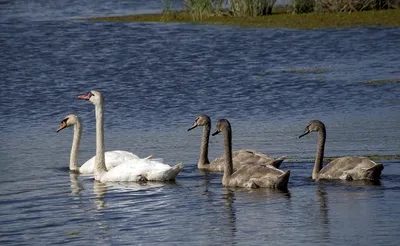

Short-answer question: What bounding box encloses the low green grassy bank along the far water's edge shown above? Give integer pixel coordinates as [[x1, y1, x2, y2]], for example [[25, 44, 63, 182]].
[[79, 9, 400, 29]]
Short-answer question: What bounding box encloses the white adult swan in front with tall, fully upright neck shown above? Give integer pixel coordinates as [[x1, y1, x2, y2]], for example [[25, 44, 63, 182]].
[[78, 90, 184, 182]]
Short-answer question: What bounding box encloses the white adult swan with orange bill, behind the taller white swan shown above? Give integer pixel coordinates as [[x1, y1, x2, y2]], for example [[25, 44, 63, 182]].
[[57, 114, 155, 174]]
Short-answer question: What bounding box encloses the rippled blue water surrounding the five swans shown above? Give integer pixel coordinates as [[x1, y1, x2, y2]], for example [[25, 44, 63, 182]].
[[0, 0, 400, 245]]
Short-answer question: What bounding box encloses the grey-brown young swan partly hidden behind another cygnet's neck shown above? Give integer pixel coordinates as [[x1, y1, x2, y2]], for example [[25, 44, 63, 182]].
[[188, 114, 286, 172]]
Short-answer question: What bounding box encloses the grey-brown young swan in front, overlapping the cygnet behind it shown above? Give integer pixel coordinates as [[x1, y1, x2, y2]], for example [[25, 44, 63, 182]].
[[212, 119, 290, 189]]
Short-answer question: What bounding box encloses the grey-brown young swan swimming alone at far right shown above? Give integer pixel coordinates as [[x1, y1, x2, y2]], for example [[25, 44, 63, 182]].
[[299, 120, 383, 180]]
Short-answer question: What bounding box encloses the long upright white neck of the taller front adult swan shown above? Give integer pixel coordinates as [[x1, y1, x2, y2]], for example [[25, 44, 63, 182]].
[[94, 100, 107, 180]]
